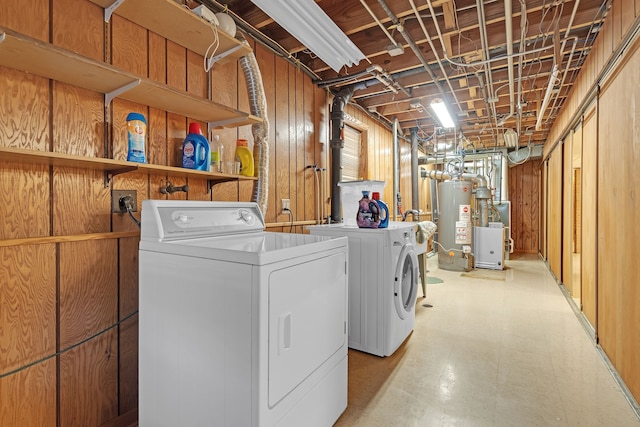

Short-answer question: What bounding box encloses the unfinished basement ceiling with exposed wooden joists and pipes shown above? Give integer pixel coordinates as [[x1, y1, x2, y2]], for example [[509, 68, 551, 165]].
[[202, 0, 611, 150]]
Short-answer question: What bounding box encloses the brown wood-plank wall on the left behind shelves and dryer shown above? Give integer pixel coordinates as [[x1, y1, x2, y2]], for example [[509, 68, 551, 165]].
[[0, 0, 376, 427]]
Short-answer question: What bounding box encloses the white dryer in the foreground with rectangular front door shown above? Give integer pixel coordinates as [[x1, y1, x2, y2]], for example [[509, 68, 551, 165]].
[[139, 200, 348, 427]]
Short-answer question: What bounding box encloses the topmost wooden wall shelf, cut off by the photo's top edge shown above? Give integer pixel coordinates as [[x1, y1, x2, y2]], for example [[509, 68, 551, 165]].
[[91, 0, 251, 63]]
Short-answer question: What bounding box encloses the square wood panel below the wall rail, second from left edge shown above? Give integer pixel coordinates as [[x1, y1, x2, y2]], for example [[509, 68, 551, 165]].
[[59, 240, 118, 349]]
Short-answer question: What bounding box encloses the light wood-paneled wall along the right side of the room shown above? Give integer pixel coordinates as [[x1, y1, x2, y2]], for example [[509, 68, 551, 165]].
[[544, 0, 640, 401]]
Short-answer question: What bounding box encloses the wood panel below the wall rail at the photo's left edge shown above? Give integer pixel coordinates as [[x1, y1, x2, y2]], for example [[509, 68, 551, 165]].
[[0, 244, 56, 372]]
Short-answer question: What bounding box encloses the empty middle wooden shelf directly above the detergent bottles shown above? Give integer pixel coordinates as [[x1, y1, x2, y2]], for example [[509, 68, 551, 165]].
[[0, 25, 260, 127]]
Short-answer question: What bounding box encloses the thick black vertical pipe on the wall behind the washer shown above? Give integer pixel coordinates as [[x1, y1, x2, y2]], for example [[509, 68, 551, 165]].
[[330, 87, 354, 222]]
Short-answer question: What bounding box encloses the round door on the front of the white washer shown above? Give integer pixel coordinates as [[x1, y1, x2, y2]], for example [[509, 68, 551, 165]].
[[393, 243, 420, 319]]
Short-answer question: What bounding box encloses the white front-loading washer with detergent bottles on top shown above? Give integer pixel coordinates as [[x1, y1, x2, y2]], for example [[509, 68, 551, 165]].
[[307, 221, 419, 356]]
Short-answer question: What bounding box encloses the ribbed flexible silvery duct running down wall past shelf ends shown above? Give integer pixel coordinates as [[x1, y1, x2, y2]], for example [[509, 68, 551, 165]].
[[240, 36, 269, 215]]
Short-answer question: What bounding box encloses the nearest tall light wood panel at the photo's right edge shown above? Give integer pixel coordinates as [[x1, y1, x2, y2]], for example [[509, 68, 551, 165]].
[[596, 36, 640, 402]]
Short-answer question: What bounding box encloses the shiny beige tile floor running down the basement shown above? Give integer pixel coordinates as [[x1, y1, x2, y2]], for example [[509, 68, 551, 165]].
[[335, 257, 640, 427]]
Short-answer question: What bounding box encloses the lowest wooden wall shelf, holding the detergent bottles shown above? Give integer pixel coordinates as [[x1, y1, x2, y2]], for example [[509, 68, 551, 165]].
[[0, 147, 257, 185]]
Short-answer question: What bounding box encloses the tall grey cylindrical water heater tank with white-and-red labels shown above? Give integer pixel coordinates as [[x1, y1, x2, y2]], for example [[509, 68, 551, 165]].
[[438, 180, 473, 271]]
